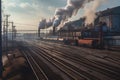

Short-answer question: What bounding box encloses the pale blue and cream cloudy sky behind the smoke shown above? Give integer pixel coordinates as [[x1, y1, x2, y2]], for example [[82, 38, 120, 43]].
[[2, 0, 120, 30]]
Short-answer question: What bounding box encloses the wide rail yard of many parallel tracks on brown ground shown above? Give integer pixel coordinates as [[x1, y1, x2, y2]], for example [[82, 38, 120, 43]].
[[14, 40, 120, 80]]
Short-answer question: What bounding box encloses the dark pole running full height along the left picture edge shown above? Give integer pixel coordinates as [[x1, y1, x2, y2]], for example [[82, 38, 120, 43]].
[[0, 0, 3, 80]]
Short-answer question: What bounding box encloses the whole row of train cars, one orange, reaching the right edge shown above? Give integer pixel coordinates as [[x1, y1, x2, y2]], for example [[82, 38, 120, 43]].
[[59, 26, 120, 49]]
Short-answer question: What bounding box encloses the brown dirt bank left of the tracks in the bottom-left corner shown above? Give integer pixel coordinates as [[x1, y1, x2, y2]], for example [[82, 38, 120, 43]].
[[3, 49, 35, 80]]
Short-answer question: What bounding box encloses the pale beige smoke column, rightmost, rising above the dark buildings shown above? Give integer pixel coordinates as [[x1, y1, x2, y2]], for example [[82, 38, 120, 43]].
[[84, 0, 107, 25]]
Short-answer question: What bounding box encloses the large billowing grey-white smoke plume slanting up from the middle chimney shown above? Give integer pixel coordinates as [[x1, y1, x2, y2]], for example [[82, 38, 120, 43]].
[[53, 0, 93, 27]]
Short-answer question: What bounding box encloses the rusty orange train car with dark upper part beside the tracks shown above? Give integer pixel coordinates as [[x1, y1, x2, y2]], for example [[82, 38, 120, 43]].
[[78, 29, 100, 48]]
